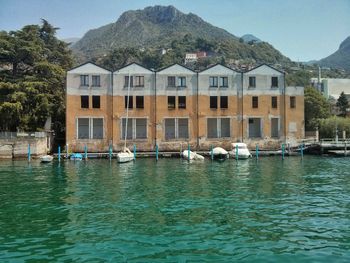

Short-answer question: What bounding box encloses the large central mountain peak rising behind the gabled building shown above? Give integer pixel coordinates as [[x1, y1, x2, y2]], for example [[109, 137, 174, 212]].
[[72, 6, 290, 63]]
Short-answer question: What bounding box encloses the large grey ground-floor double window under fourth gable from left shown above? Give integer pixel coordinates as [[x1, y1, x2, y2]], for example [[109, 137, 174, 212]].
[[207, 118, 231, 138]]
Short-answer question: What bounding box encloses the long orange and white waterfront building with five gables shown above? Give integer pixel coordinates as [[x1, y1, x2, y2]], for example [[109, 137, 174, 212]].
[[66, 63, 304, 152]]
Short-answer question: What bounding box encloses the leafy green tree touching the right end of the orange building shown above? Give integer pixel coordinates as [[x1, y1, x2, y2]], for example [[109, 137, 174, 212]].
[[304, 87, 331, 130]]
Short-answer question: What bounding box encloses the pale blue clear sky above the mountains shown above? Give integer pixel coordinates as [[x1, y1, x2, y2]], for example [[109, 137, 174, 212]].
[[0, 0, 350, 61]]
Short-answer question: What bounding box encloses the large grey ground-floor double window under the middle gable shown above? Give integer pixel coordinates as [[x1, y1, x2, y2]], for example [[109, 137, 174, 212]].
[[164, 118, 189, 140]]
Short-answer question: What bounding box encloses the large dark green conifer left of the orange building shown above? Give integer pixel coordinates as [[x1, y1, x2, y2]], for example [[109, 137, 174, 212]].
[[0, 20, 73, 140]]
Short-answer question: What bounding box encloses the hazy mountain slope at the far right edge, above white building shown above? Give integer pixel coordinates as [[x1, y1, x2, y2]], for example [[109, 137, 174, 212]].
[[317, 36, 350, 70]]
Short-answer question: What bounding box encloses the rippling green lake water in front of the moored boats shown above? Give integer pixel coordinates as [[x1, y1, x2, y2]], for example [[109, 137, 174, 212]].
[[0, 156, 350, 262]]
